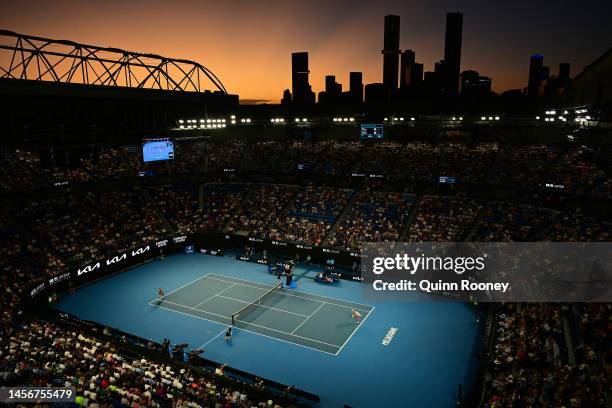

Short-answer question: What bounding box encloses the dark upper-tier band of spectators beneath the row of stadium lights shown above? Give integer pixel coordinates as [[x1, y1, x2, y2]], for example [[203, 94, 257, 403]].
[[0, 140, 612, 199]]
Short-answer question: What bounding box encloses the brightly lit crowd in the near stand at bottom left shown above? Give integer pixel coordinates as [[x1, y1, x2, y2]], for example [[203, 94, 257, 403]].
[[0, 321, 280, 408]]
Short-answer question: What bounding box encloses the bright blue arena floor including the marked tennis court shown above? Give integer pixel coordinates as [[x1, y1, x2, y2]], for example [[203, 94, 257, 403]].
[[57, 254, 480, 408]]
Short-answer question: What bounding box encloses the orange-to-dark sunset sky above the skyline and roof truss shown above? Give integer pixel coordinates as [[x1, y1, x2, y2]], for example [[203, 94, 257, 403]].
[[0, 0, 612, 102]]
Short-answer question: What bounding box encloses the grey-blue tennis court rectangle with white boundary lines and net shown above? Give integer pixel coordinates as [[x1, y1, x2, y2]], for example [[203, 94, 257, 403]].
[[149, 273, 374, 355]]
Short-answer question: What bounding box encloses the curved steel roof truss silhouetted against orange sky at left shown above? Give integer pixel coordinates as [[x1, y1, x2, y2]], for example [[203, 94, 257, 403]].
[[0, 30, 227, 94]]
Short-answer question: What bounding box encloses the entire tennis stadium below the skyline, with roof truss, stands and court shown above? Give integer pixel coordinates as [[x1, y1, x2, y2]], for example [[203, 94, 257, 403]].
[[0, 31, 612, 407]]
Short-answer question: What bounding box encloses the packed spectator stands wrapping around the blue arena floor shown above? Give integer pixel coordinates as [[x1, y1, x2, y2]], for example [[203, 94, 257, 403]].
[[0, 140, 612, 407]]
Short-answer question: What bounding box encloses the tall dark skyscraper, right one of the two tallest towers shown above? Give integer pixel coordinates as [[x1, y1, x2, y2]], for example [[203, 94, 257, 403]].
[[441, 13, 463, 95]]
